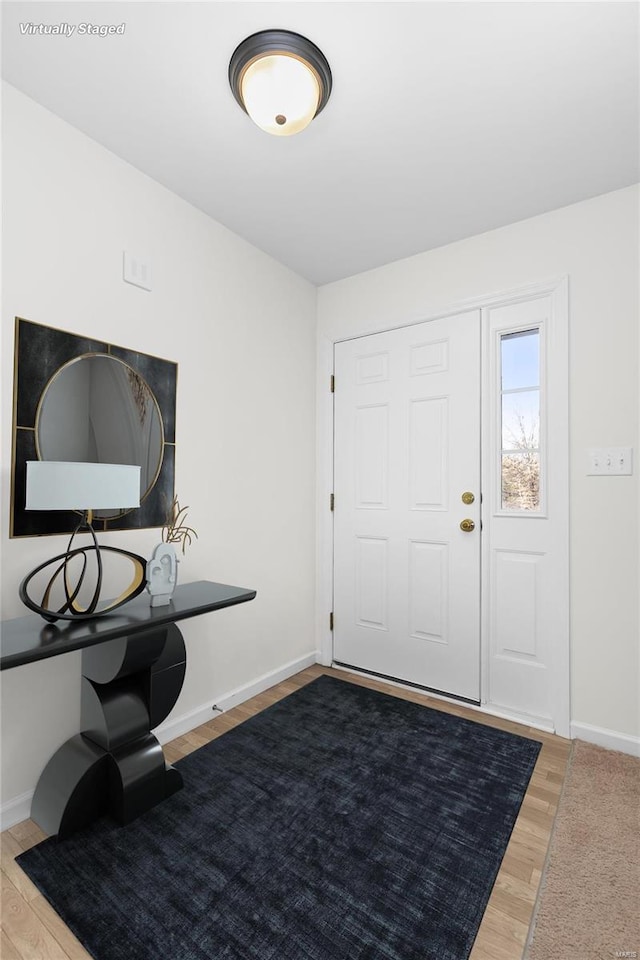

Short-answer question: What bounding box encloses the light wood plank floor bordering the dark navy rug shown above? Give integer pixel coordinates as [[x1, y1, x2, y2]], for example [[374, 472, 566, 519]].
[[0, 666, 571, 960]]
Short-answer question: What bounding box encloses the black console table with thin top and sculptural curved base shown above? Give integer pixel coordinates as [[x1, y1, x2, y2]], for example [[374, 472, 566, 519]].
[[0, 580, 256, 838]]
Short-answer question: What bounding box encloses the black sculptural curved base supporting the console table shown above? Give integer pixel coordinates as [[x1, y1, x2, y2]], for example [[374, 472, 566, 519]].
[[31, 624, 186, 838]]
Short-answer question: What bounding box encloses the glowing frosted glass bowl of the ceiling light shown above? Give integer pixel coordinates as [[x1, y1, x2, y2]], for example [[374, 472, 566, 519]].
[[241, 53, 320, 137]]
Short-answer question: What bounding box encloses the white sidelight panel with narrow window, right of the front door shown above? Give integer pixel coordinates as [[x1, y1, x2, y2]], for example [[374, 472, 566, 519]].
[[486, 294, 568, 724]]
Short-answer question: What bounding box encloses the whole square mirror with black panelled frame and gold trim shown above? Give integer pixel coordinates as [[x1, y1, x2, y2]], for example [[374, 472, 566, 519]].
[[10, 318, 177, 537]]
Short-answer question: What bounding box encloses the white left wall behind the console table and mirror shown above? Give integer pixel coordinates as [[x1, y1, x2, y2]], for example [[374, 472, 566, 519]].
[[1, 86, 316, 802]]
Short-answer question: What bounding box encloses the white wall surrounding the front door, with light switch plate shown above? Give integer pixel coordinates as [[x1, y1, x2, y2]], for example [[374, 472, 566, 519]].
[[318, 187, 640, 737]]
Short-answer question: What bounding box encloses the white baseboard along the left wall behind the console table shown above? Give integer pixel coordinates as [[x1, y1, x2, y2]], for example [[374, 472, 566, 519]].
[[0, 650, 318, 830]]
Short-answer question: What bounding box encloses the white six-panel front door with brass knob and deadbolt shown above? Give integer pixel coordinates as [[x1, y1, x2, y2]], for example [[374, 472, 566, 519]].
[[333, 310, 480, 701]]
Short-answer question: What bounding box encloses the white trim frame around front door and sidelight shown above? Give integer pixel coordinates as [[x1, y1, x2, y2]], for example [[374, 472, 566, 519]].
[[316, 275, 570, 737]]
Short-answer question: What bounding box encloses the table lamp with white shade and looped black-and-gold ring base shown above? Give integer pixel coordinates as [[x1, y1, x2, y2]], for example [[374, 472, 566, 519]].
[[19, 460, 146, 623]]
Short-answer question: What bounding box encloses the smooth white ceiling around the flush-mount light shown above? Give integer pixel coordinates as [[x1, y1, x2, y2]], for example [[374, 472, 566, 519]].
[[3, 0, 639, 284]]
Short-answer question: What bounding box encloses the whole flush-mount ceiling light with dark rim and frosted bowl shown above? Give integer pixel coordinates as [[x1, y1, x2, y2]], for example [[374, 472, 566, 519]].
[[229, 30, 332, 137]]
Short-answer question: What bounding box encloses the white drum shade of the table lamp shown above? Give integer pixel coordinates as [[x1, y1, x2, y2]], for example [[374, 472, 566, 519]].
[[25, 460, 140, 510]]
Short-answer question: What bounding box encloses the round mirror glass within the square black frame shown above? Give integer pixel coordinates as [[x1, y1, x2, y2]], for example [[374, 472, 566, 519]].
[[35, 353, 164, 519]]
